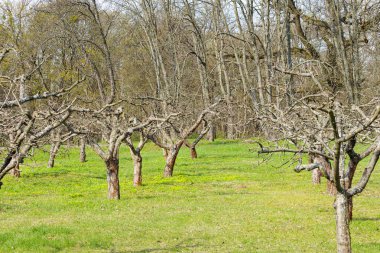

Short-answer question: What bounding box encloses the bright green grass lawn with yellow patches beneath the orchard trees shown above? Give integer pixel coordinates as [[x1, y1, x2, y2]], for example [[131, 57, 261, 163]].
[[0, 140, 380, 253]]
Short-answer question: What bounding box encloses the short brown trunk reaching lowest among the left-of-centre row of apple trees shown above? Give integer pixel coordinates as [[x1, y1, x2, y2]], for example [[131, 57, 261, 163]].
[[106, 158, 120, 199]]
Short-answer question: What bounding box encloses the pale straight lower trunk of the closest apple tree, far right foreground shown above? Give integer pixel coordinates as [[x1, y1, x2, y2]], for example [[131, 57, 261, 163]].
[[335, 193, 351, 253]]
